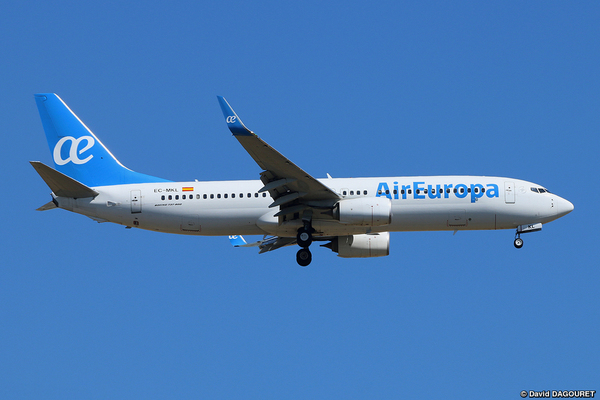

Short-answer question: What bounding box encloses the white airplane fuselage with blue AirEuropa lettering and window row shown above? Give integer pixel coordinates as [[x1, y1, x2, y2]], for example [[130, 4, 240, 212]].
[[56, 176, 573, 236]]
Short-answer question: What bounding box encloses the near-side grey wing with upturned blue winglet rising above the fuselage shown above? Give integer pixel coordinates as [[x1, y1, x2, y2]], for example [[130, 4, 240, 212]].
[[217, 96, 340, 215]]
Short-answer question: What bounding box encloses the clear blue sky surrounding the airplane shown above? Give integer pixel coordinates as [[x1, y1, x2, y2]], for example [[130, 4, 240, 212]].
[[0, 1, 600, 399]]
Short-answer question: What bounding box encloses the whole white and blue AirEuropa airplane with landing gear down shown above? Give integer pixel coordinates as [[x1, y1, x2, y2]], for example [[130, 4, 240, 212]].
[[30, 93, 574, 266]]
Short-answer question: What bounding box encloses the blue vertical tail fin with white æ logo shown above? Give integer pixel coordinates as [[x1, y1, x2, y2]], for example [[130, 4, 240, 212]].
[[35, 93, 167, 187]]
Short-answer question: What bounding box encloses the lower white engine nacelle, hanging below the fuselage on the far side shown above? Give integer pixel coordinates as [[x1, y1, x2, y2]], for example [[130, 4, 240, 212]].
[[325, 232, 390, 258]]
